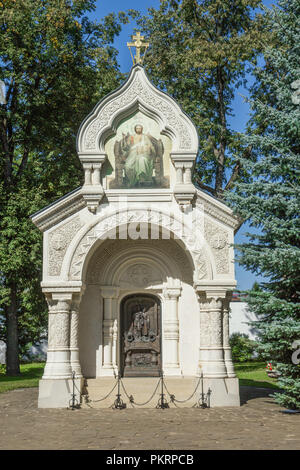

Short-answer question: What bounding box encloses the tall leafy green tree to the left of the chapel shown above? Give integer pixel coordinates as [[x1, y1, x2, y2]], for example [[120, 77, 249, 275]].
[[0, 0, 127, 375]]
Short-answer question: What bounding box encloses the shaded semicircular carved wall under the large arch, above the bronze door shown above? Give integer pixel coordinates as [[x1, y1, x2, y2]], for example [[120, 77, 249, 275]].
[[84, 240, 193, 290]]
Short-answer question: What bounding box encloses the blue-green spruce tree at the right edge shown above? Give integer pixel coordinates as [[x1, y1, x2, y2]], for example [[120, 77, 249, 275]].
[[227, 0, 300, 409]]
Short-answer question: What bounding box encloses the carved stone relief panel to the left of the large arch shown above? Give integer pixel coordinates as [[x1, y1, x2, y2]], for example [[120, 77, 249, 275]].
[[48, 217, 83, 276]]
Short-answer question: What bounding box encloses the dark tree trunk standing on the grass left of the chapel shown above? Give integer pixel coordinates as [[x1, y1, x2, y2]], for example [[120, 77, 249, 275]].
[[6, 282, 20, 376]]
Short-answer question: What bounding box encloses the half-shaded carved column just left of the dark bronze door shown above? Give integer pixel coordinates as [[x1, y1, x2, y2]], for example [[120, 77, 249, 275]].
[[100, 287, 118, 376]]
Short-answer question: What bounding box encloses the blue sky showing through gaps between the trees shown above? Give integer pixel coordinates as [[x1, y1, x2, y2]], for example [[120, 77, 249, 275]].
[[89, 0, 276, 290]]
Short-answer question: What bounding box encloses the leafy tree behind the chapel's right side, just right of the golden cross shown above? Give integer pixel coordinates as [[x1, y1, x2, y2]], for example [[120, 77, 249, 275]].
[[138, 0, 269, 198]]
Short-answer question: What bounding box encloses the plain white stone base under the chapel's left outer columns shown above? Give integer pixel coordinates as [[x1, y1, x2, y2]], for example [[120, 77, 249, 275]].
[[38, 378, 83, 408]]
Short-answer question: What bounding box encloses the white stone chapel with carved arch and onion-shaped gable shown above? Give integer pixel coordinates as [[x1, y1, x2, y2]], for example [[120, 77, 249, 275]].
[[32, 59, 240, 408]]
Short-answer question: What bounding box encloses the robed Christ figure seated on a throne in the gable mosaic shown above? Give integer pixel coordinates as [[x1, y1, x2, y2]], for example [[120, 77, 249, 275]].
[[114, 124, 164, 188]]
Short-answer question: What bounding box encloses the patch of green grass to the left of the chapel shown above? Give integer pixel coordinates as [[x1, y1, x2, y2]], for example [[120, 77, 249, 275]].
[[0, 362, 45, 393]]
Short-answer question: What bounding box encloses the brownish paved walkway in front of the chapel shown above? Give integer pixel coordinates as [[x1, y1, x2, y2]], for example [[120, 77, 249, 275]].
[[0, 387, 300, 450]]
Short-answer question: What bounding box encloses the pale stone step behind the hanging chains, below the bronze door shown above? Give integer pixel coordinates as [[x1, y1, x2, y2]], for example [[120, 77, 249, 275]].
[[82, 377, 206, 408]]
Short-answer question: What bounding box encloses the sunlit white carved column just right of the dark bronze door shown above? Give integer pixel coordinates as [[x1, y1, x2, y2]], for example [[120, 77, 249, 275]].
[[163, 288, 181, 375]]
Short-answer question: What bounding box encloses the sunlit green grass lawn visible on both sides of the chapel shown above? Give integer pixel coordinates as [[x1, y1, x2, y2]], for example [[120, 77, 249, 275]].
[[0, 362, 278, 393]]
